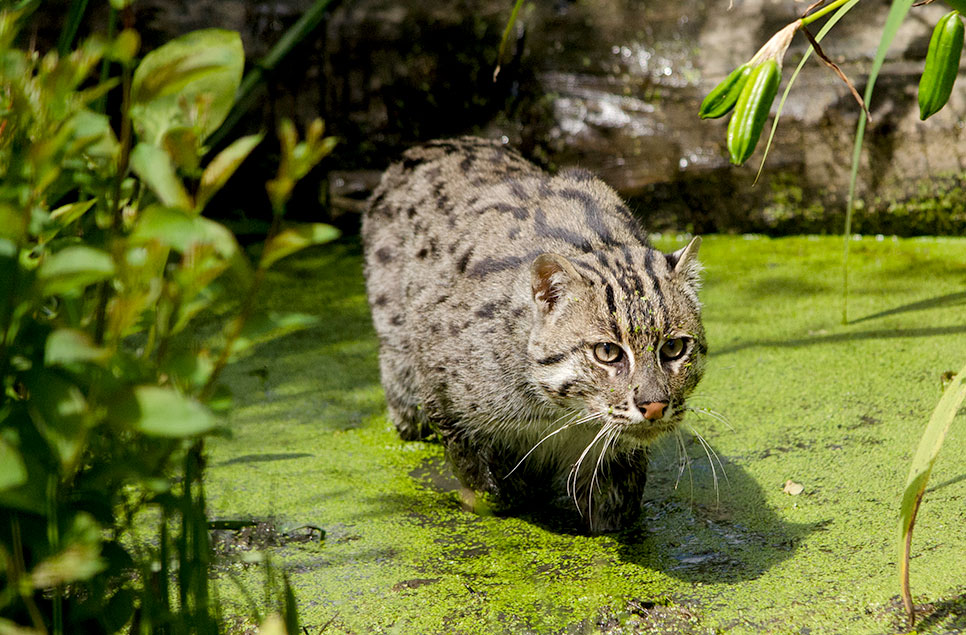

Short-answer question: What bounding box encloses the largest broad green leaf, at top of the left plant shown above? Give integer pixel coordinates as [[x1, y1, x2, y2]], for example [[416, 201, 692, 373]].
[[131, 29, 245, 145]]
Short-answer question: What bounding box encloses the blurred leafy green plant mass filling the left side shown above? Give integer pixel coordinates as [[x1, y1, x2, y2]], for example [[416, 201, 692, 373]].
[[0, 7, 337, 633]]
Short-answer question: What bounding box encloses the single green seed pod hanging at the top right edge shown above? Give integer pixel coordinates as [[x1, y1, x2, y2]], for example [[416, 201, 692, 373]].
[[919, 11, 964, 120]]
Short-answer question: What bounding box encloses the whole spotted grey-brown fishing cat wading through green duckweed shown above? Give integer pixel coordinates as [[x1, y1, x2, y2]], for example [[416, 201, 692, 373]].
[[362, 137, 707, 532]]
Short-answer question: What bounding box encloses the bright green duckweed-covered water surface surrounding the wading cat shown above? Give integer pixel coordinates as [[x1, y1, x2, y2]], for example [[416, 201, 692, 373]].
[[208, 236, 966, 633]]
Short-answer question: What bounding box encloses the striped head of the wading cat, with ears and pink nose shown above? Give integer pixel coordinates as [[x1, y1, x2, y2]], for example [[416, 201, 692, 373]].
[[528, 237, 707, 443]]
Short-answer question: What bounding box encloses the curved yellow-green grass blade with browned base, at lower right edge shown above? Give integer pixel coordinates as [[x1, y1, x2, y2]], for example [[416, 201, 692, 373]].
[[899, 366, 966, 627]]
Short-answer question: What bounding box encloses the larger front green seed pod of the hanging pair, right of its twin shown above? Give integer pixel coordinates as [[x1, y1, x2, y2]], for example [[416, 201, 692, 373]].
[[728, 59, 782, 165]]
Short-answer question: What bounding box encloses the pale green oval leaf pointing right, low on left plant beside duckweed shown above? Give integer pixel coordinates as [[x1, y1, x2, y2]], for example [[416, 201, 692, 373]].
[[108, 386, 215, 438]]
